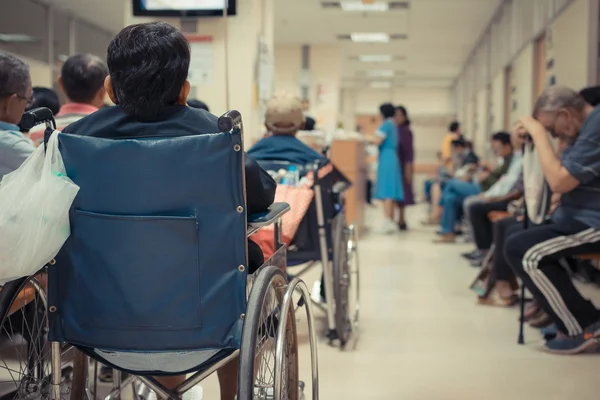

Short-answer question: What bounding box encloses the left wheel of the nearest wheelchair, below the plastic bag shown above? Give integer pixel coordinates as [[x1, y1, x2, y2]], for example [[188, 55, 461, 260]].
[[0, 274, 86, 400]]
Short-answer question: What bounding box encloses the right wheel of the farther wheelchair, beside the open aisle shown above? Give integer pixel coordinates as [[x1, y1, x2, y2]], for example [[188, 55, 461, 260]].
[[333, 219, 358, 348]]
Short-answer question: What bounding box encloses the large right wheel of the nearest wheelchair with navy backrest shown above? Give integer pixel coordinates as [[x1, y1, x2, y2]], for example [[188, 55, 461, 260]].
[[238, 266, 299, 400]]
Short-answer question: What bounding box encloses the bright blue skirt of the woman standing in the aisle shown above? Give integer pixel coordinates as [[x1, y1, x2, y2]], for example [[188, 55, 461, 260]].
[[375, 148, 404, 201]]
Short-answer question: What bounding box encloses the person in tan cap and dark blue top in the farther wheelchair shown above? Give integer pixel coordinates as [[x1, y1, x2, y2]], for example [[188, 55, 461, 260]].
[[248, 93, 326, 165]]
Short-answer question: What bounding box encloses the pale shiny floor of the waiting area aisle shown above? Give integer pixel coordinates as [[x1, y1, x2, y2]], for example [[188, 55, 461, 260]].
[[134, 208, 600, 400]]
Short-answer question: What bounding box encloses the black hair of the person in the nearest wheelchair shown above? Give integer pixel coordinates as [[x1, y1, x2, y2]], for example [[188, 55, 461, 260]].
[[107, 22, 190, 120]]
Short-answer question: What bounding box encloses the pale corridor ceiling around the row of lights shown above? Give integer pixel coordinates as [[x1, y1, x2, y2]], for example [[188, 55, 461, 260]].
[[275, 0, 502, 87]]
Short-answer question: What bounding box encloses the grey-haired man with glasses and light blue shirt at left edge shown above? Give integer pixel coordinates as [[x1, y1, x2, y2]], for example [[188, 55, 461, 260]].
[[0, 52, 34, 179]]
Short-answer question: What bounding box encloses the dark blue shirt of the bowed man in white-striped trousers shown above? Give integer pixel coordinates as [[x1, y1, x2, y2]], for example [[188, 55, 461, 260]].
[[553, 107, 600, 229]]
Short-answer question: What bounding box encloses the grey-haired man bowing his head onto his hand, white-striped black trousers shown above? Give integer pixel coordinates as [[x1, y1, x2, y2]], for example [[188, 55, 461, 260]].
[[504, 86, 600, 354]]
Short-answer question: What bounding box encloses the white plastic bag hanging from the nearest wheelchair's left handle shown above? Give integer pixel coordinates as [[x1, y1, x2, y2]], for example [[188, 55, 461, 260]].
[[0, 131, 79, 284]]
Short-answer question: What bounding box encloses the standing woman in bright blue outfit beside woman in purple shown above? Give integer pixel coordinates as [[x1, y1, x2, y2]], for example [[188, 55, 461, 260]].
[[373, 103, 404, 234]]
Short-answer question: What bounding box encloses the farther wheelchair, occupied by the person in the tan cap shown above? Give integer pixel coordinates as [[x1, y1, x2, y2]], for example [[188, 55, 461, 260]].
[[258, 159, 360, 349]]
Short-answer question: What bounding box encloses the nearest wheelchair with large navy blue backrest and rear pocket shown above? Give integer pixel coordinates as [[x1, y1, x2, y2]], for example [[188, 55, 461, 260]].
[[0, 108, 319, 400]]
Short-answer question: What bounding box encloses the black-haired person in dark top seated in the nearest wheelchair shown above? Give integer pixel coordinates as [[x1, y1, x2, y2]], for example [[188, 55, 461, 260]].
[[58, 22, 276, 400]]
